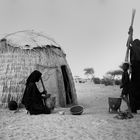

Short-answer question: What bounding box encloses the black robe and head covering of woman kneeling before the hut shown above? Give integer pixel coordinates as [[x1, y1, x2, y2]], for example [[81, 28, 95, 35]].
[[22, 70, 51, 114]]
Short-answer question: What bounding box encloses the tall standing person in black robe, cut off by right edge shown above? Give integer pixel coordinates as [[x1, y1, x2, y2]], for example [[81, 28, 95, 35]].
[[130, 39, 140, 113]]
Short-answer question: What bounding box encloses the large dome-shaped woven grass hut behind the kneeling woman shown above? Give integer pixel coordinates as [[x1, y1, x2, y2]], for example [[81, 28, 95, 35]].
[[0, 30, 77, 107]]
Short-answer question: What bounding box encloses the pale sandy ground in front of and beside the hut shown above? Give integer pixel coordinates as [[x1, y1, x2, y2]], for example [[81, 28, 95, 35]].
[[0, 83, 140, 140]]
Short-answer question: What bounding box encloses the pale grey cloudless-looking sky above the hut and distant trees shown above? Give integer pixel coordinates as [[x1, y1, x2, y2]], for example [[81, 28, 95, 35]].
[[0, 0, 140, 77]]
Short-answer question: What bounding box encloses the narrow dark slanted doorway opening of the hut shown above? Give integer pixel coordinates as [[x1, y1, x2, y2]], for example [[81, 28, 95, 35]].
[[61, 65, 72, 105]]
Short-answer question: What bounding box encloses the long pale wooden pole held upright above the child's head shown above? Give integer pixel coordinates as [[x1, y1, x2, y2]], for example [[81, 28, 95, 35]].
[[125, 9, 136, 62]]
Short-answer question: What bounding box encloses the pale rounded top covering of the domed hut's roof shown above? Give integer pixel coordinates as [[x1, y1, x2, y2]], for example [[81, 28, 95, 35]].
[[0, 30, 60, 49]]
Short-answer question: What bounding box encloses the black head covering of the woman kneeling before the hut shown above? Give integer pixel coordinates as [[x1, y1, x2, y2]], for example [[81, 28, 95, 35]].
[[26, 70, 42, 85]]
